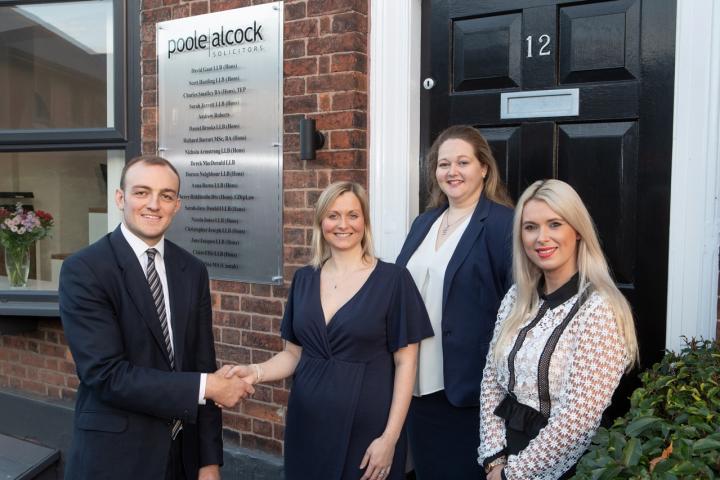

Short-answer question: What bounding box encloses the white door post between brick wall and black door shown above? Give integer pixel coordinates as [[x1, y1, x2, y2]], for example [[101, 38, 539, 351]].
[[368, 0, 421, 261]]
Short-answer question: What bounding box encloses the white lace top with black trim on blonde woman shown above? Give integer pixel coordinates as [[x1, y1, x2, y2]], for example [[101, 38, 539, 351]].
[[478, 285, 629, 480]]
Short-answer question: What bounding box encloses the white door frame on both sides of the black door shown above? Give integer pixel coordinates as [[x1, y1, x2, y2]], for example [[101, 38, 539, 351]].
[[368, 0, 720, 344]]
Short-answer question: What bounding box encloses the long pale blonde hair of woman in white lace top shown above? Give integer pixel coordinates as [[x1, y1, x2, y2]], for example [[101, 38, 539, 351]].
[[494, 180, 639, 369]]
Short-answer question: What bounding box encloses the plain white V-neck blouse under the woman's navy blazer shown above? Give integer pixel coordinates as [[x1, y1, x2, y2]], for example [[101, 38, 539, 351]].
[[407, 215, 472, 396]]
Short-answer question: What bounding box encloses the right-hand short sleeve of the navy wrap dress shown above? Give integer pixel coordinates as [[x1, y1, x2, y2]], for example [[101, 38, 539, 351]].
[[386, 267, 434, 352]]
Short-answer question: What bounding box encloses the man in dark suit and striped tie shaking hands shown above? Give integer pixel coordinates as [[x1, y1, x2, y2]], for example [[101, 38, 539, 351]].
[[59, 156, 252, 480]]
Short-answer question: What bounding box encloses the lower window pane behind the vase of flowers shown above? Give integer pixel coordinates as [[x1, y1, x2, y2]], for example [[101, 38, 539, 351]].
[[0, 151, 112, 288]]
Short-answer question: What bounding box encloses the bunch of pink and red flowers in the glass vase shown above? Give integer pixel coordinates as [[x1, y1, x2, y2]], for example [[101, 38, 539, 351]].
[[0, 203, 54, 250]]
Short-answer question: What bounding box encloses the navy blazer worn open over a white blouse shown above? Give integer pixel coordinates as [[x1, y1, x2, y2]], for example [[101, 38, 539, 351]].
[[396, 195, 513, 407]]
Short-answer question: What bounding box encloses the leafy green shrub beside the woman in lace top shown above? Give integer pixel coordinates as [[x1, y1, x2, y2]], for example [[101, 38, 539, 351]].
[[574, 339, 720, 480]]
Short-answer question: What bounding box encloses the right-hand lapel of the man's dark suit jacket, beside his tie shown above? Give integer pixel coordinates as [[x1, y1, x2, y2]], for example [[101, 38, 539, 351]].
[[164, 240, 190, 369]]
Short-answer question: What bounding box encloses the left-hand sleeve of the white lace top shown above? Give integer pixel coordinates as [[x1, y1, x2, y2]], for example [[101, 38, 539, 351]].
[[478, 285, 516, 465]]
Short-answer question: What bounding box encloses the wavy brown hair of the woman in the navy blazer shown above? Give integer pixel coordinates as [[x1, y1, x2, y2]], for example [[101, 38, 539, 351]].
[[427, 125, 513, 208]]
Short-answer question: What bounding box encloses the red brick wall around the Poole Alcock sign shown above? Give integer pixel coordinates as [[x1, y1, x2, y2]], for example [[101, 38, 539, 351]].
[[0, 0, 369, 460]]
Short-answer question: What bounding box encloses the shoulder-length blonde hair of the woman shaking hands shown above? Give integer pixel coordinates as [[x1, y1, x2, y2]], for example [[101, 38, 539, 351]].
[[310, 182, 375, 269]]
